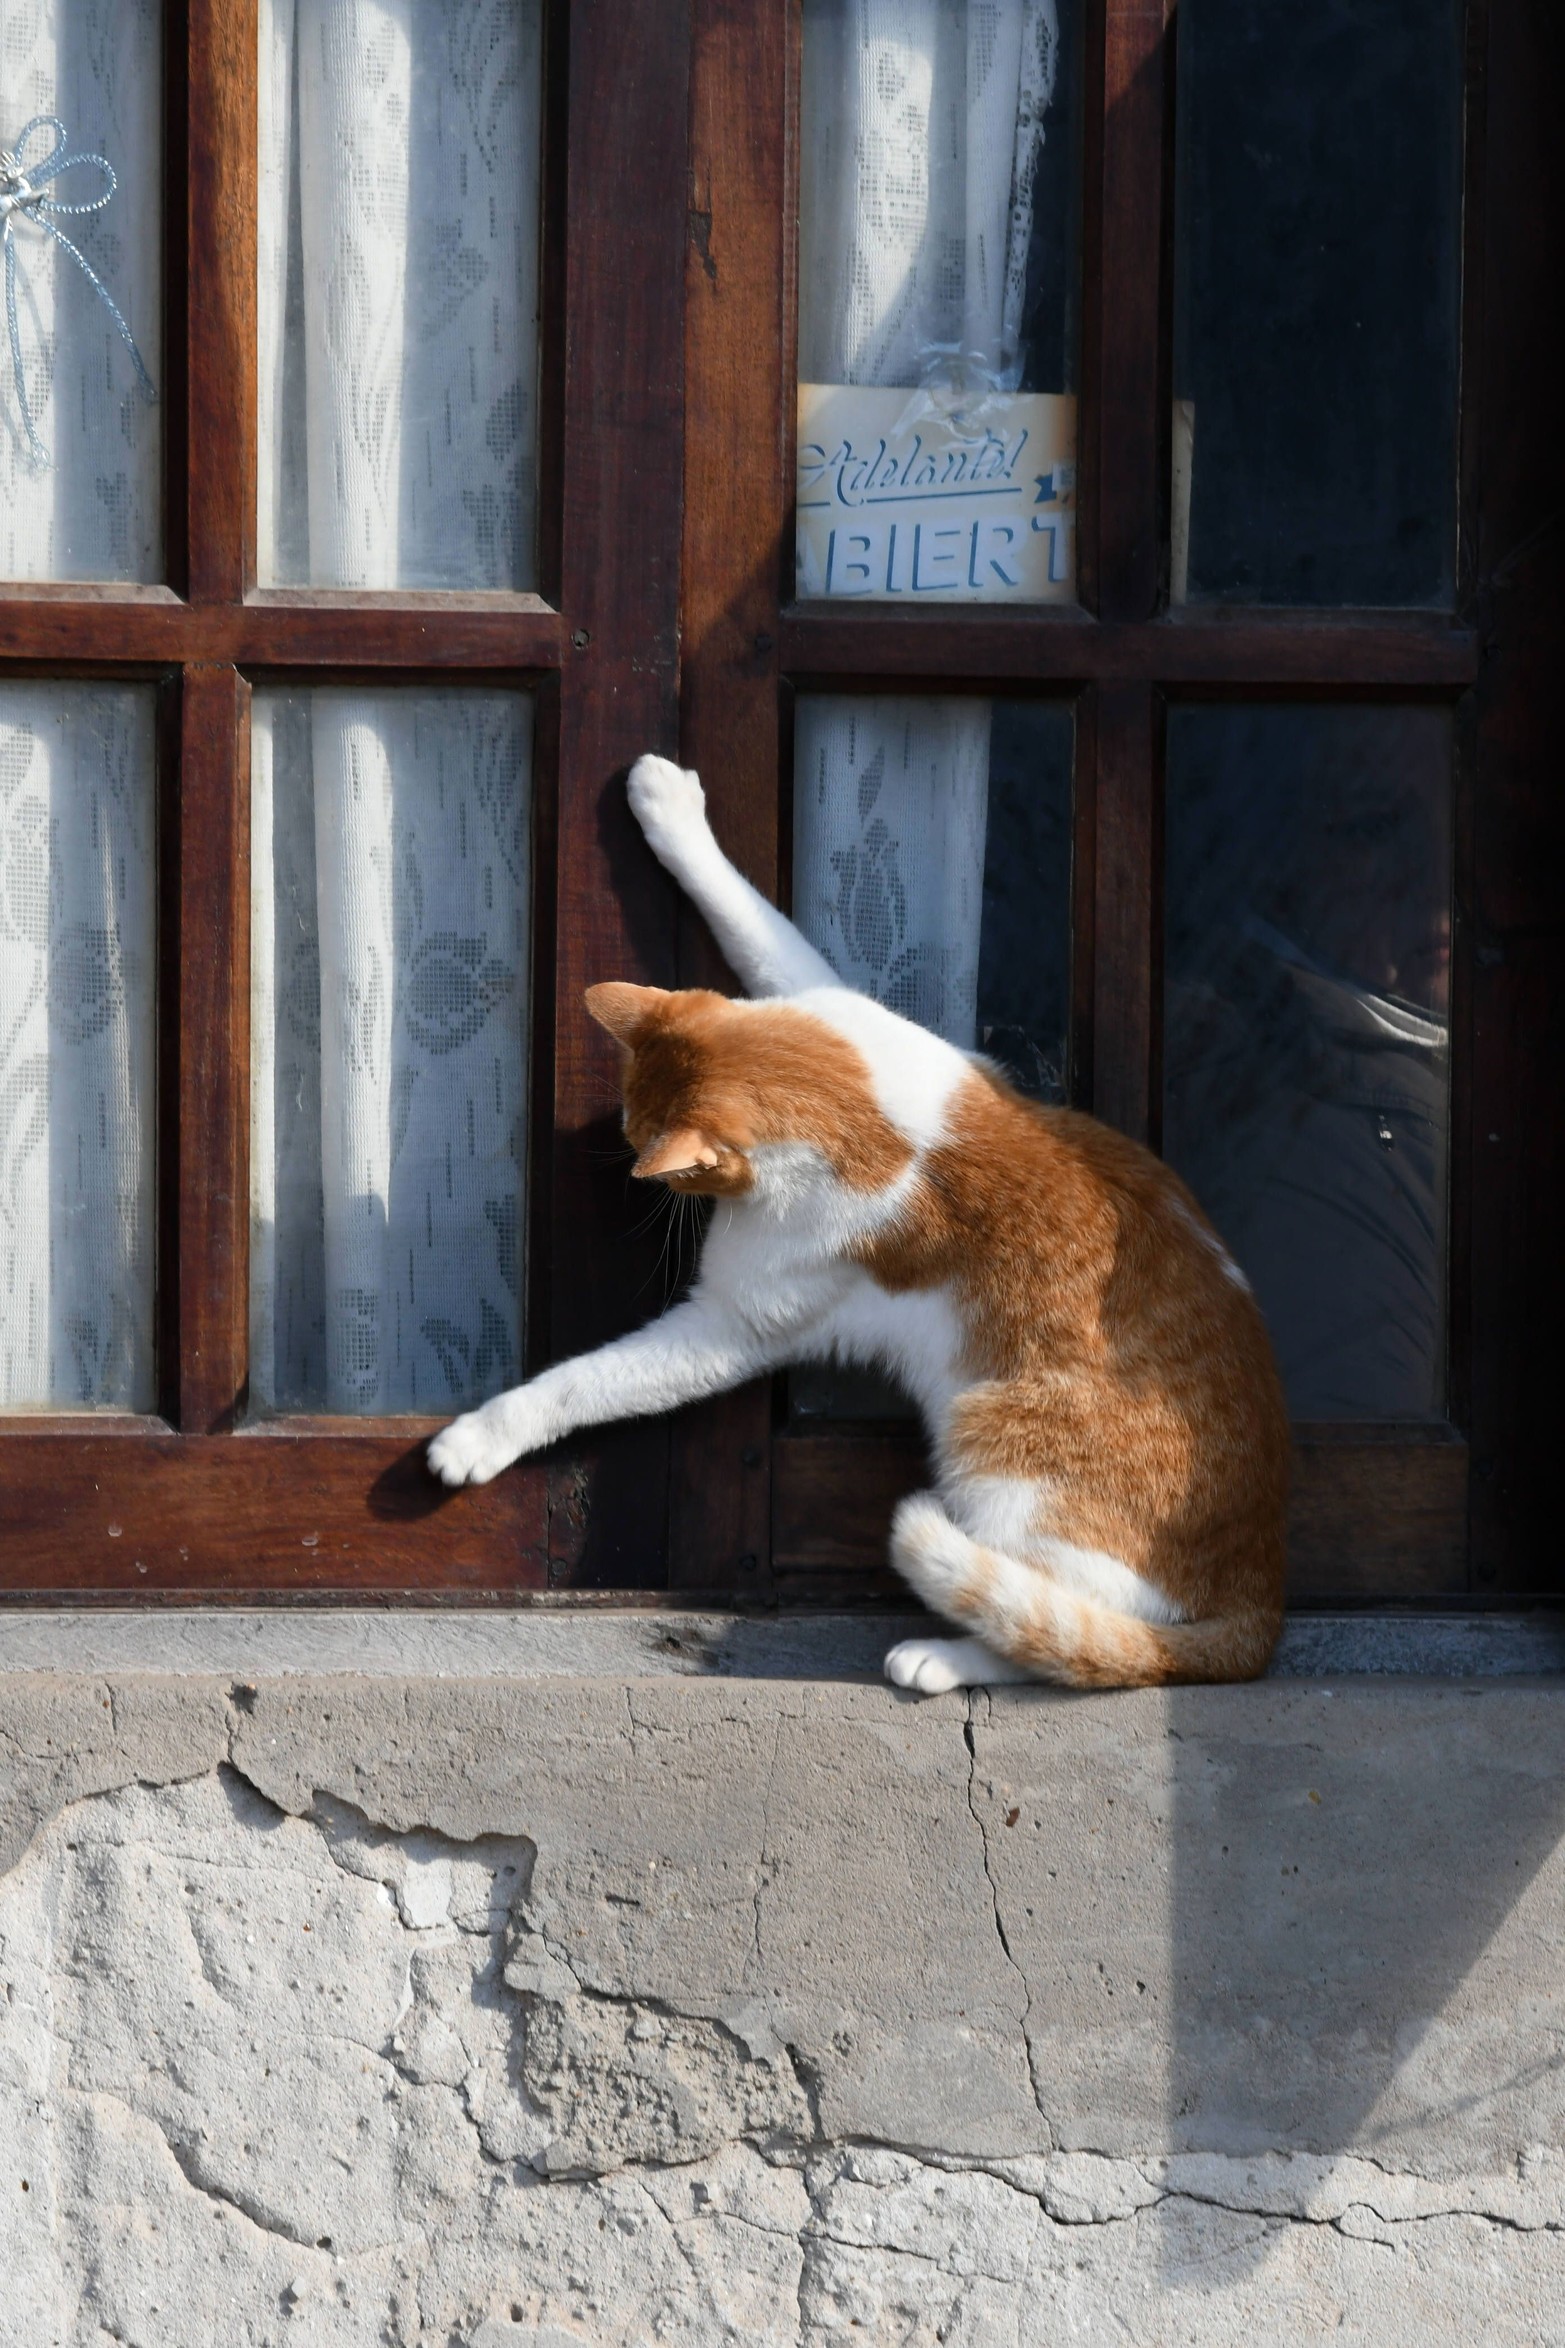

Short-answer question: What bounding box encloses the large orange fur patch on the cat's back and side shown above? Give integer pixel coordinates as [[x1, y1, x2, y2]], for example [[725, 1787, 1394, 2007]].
[[863, 1071, 1290, 1618]]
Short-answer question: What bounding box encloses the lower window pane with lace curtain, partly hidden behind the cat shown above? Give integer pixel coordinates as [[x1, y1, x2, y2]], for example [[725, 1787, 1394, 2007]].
[[791, 693, 1075, 1418]]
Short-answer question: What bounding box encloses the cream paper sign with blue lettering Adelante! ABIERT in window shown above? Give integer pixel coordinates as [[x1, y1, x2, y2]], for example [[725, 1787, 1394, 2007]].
[[798, 383, 1077, 603]]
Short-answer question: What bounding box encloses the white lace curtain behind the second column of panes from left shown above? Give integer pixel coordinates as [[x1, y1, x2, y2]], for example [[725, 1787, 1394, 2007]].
[[251, 0, 542, 1413]]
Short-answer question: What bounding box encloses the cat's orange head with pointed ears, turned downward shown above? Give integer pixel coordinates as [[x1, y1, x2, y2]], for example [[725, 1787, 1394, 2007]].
[[587, 984, 910, 1197]]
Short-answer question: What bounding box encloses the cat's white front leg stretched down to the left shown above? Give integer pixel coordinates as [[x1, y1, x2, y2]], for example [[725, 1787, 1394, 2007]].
[[429, 1296, 777, 1484]]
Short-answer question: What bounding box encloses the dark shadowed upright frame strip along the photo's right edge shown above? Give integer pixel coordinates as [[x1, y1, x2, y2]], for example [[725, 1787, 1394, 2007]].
[[1464, 0, 1565, 1597]]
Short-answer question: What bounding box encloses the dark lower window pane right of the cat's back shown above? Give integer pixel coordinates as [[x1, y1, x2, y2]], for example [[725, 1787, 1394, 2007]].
[[1164, 707, 1450, 1418]]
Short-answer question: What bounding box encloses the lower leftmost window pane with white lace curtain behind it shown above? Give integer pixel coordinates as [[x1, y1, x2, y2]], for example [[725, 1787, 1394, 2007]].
[[0, 681, 157, 1411]]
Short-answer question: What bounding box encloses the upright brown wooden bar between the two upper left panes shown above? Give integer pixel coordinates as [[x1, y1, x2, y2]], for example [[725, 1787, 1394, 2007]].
[[186, 0, 260, 605]]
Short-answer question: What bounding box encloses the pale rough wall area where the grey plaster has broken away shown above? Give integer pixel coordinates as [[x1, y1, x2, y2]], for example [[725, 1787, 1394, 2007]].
[[0, 1770, 1565, 2348]]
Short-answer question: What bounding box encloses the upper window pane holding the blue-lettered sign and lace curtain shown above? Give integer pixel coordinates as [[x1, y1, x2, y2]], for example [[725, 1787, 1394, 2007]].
[[798, 0, 1082, 603]]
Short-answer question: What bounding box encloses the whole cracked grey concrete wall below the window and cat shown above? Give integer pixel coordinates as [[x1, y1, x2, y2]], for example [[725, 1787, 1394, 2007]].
[[0, 1674, 1565, 2348]]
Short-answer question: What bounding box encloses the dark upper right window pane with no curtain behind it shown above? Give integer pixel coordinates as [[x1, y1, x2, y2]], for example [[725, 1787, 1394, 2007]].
[[1173, 0, 1462, 603]]
